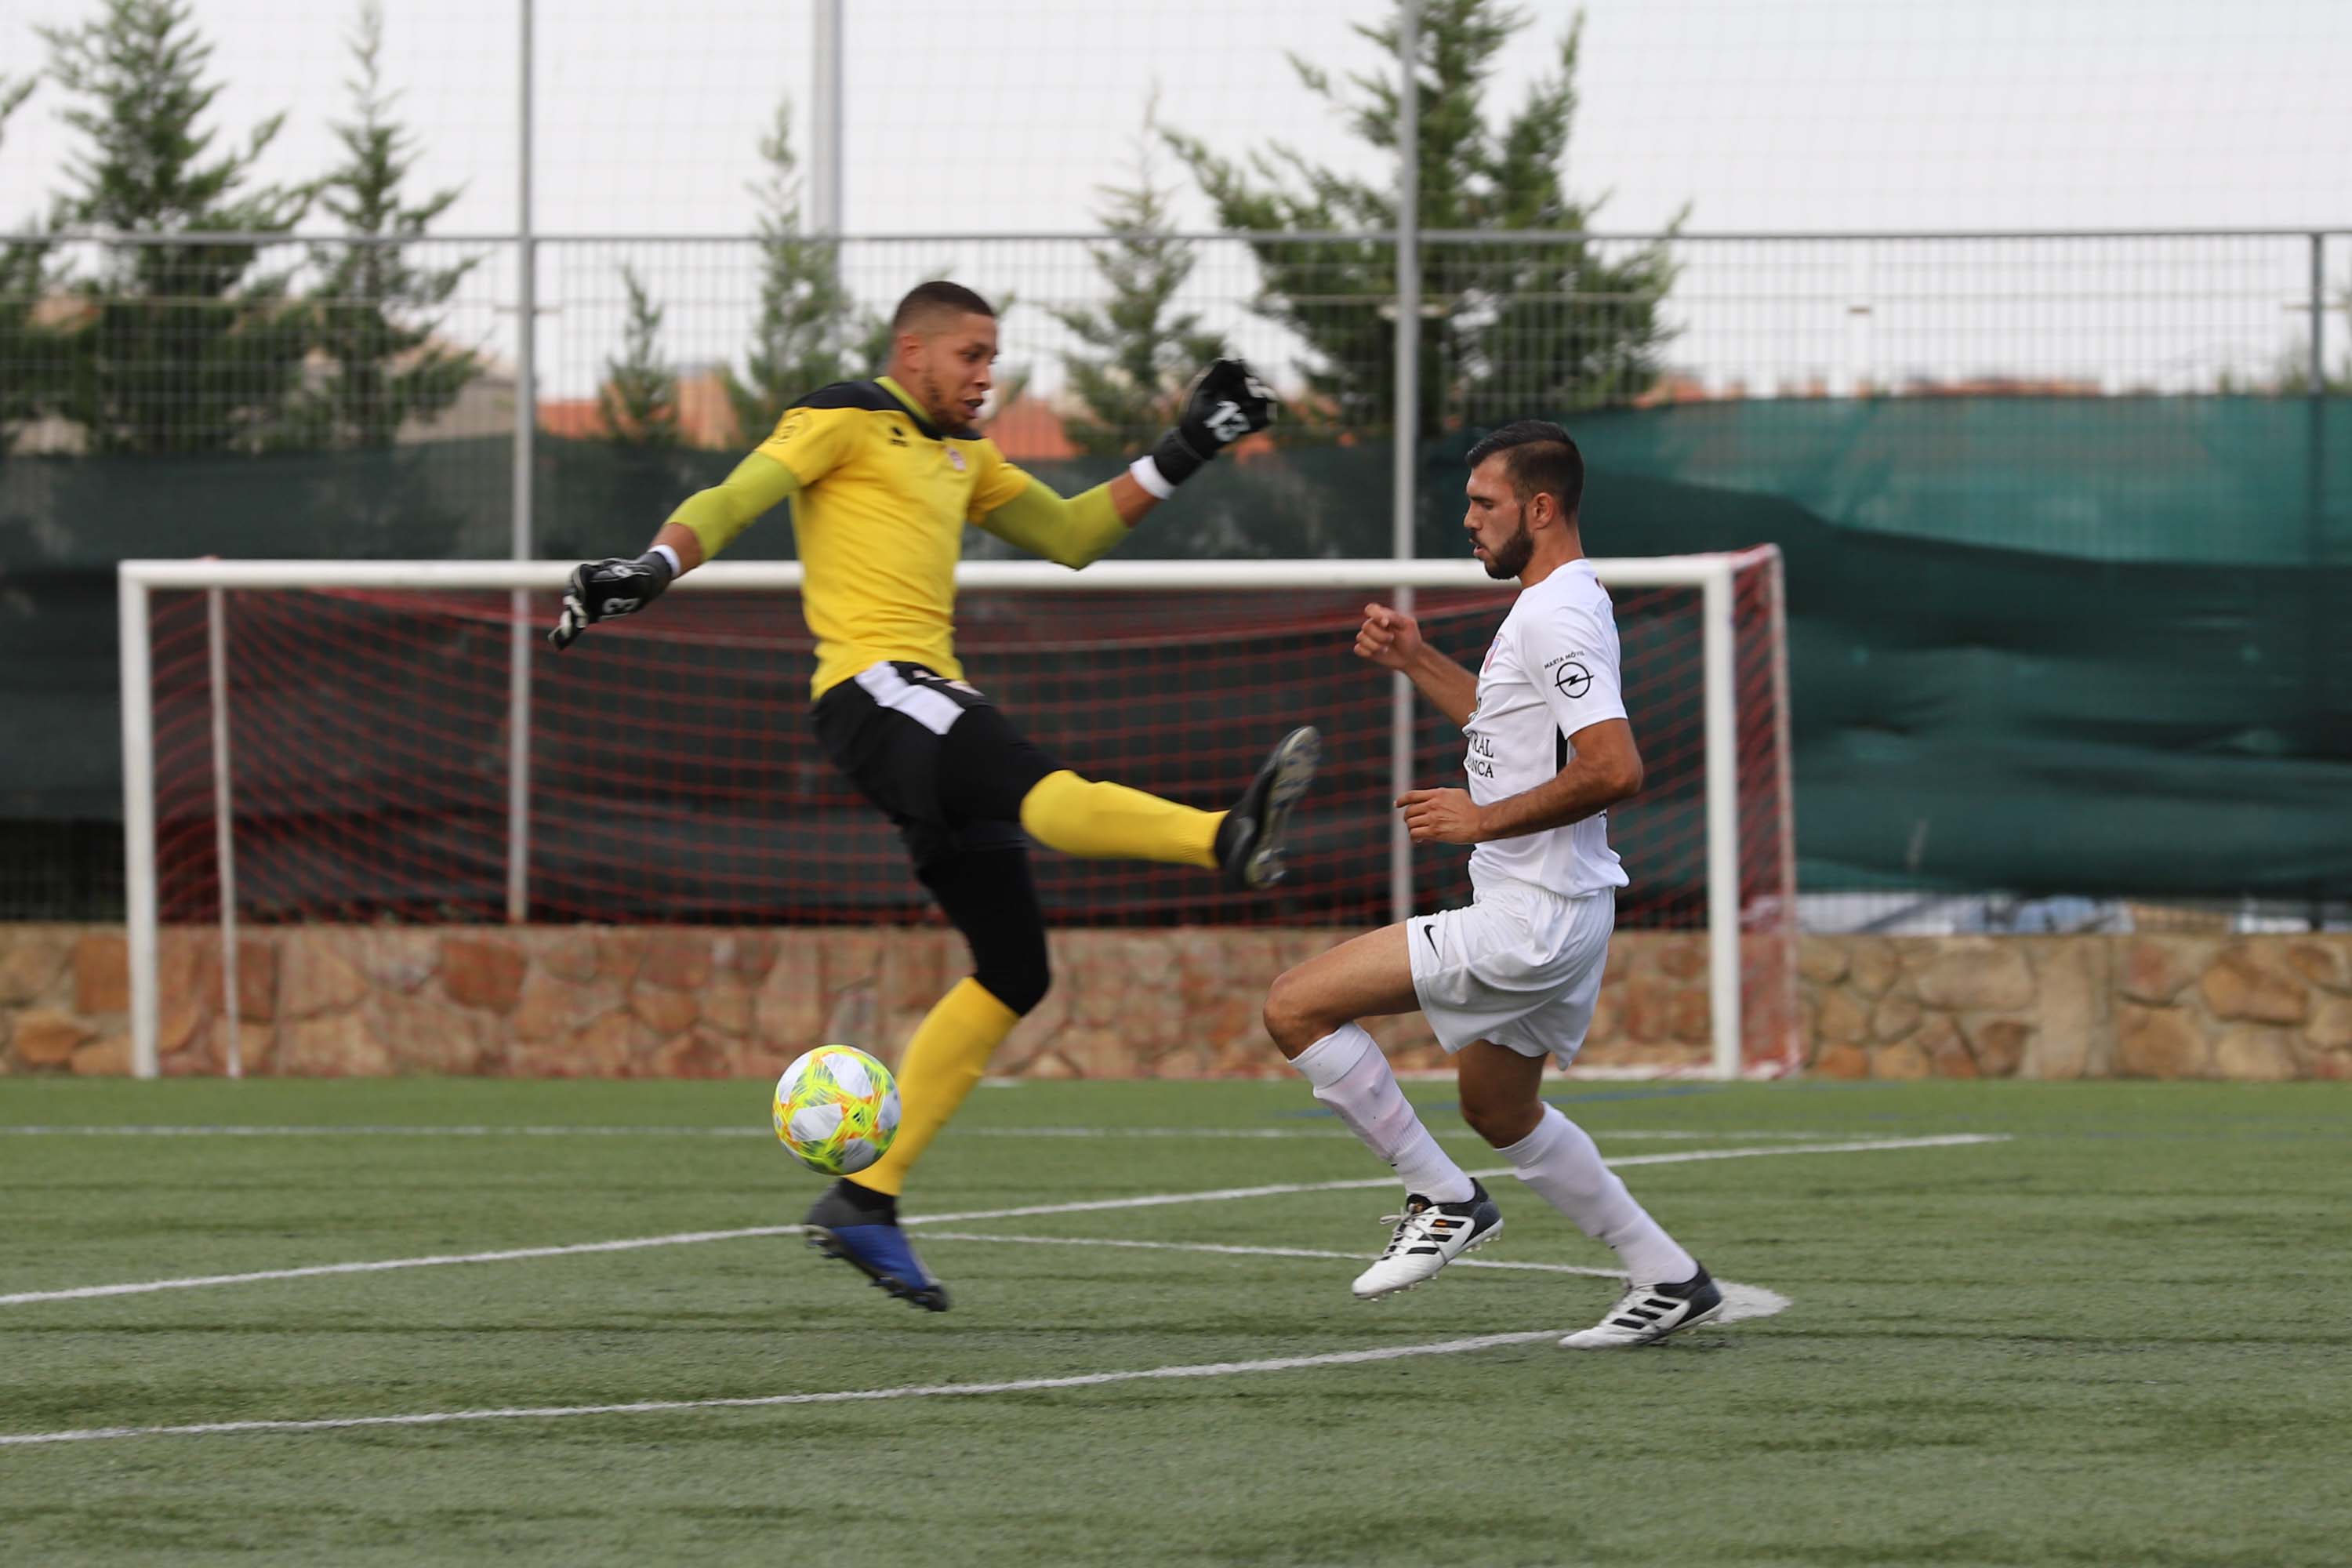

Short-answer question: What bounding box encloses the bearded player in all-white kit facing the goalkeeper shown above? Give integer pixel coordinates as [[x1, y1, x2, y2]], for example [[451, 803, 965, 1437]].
[[1265, 421, 1724, 1349]]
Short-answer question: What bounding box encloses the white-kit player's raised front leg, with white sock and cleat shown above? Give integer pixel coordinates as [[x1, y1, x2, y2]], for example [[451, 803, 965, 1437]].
[[1265, 926, 1503, 1300]]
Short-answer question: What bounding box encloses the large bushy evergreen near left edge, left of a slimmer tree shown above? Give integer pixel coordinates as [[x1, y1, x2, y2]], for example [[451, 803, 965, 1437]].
[[40, 0, 310, 452]]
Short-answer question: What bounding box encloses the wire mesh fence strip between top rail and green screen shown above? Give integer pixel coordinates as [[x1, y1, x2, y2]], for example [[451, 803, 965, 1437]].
[[18, 230, 2352, 451]]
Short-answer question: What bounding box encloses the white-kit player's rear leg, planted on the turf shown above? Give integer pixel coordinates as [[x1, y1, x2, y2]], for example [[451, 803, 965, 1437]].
[[1454, 1039, 1724, 1349]]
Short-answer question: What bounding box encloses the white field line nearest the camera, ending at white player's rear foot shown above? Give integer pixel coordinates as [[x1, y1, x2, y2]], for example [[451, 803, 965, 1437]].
[[0, 1328, 1562, 1448]]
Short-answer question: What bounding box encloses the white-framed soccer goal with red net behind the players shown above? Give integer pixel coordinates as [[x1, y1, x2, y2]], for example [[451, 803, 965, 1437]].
[[120, 548, 1799, 1076]]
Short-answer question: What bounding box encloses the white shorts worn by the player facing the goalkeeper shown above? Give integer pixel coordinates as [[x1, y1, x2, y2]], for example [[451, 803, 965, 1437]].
[[1404, 881, 1616, 1067]]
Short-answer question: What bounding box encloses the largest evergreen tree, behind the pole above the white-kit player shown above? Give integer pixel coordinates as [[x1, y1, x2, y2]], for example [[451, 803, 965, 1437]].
[[1167, 0, 1679, 440]]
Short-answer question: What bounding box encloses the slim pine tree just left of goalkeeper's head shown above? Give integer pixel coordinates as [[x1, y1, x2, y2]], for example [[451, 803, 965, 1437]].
[[720, 99, 870, 442]]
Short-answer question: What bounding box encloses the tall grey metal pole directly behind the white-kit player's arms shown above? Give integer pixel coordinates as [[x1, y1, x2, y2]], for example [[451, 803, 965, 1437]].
[[1388, 0, 1421, 921]]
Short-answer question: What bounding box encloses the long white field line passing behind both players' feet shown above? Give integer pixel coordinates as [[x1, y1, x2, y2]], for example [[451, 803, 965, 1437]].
[[0, 1133, 2006, 1307]]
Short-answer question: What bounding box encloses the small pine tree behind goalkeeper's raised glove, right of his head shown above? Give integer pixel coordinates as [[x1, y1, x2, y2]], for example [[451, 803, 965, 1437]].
[[1051, 94, 1225, 456]]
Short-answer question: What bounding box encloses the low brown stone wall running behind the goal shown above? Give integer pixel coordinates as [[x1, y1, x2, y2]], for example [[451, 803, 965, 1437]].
[[0, 926, 2352, 1079]]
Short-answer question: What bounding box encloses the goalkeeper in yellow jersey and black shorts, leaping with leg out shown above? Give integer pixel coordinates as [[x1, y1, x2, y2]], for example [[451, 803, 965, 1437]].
[[550, 282, 1319, 1312]]
